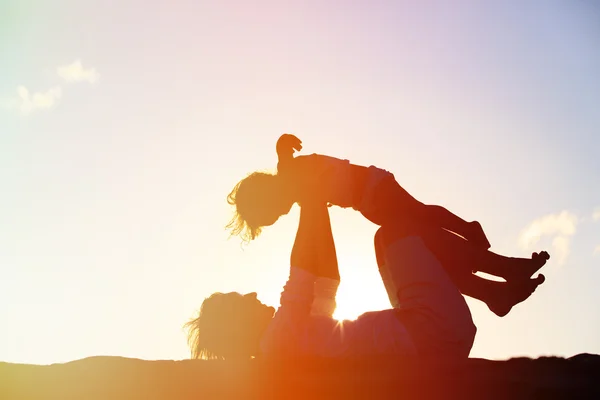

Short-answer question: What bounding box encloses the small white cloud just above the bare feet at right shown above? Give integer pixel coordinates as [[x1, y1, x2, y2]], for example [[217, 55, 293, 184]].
[[519, 211, 578, 265]]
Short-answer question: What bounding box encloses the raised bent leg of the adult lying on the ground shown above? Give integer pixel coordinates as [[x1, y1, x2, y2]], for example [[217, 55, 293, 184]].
[[375, 228, 477, 358]]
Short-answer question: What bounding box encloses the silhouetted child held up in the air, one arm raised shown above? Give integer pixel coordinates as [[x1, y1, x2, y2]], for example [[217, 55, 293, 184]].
[[227, 134, 548, 279]]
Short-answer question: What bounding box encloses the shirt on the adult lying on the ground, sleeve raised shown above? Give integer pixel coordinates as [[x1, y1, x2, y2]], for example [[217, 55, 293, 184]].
[[261, 267, 417, 357]]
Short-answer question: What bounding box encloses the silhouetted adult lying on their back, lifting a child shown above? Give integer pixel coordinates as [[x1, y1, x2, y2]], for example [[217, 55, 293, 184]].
[[187, 201, 544, 359]]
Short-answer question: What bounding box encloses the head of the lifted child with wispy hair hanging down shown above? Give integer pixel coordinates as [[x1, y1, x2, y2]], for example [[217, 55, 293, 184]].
[[227, 172, 294, 242]]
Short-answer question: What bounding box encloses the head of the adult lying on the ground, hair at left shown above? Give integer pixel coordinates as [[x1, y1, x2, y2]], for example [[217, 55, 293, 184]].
[[185, 292, 275, 360]]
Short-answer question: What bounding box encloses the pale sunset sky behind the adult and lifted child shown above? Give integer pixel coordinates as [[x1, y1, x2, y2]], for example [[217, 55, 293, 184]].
[[0, 0, 600, 364]]
